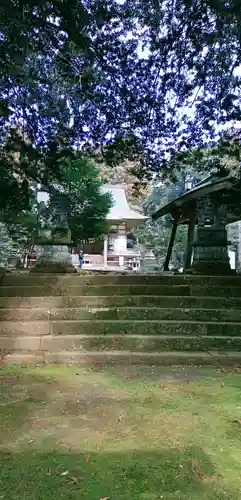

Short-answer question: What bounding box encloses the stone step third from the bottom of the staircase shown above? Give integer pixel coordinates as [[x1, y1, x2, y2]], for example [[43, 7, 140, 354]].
[[0, 319, 241, 337]]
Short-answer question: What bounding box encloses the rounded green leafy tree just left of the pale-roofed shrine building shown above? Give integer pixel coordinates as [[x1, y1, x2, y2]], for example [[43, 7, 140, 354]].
[[41, 153, 112, 245]]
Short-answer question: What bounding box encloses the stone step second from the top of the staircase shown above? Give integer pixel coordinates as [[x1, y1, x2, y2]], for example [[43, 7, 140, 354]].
[[0, 284, 241, 298]]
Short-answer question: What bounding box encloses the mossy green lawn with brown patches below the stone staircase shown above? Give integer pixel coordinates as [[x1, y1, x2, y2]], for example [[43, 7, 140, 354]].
[[0, 366, 241, 500]]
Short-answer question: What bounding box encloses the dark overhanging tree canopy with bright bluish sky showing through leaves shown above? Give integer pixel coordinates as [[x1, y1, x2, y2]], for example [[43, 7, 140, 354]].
[[0, 0, 241, 208]]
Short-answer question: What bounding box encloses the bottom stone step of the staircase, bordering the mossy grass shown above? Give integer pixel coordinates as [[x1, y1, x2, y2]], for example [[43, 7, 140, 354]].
[[3, 350, 241, 368]]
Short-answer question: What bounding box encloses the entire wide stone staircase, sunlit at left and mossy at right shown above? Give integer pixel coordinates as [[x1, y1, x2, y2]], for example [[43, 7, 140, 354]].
[[0, 273, 241, 365]]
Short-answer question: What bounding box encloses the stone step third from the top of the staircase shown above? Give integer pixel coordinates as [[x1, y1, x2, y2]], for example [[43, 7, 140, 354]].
[[0, 295, 241, 310]]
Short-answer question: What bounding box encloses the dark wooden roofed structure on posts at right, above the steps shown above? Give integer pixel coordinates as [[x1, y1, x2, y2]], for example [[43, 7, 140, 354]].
[[152, 172, 241, 275]]
